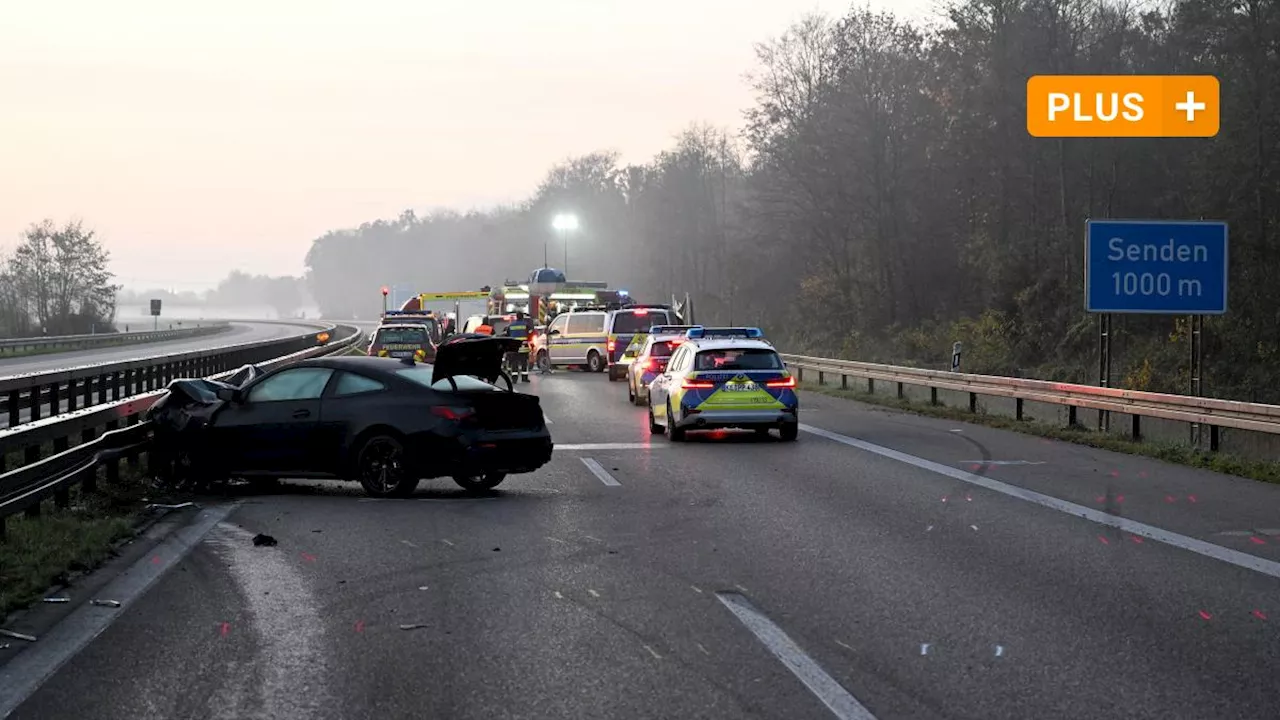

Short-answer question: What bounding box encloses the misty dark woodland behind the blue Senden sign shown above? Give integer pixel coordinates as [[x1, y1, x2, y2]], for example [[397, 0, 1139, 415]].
[[306, 0, 1280, 401]]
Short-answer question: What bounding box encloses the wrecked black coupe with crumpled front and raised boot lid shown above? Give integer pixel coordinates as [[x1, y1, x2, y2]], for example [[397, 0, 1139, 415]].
[[148, 334, 552, 497]]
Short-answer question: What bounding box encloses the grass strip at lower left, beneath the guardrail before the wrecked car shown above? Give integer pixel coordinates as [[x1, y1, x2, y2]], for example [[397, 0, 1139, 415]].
[[0, 465, 147, 621]]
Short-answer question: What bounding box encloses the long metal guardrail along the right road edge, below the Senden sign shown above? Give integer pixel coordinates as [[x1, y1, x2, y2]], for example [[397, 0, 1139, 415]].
[[782, 354, 1280, 451]]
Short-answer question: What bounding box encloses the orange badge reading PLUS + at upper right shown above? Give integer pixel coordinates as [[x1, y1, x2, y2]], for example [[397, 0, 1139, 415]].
[[1027, 76, 1220, 137]]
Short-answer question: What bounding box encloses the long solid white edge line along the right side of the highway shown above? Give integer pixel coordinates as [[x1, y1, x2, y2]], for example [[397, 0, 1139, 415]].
[[800, 424, 1280, 578]]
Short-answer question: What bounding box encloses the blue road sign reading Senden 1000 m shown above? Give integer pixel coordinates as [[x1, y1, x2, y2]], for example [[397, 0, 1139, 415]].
[[1084, 220, 1228, 315]]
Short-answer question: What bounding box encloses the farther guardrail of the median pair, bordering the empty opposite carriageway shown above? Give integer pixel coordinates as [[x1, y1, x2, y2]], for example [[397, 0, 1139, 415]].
[[0, 320, 334, 430]]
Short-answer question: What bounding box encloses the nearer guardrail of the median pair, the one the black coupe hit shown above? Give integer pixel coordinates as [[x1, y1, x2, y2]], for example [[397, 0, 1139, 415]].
[[0, 325, 362, 539]]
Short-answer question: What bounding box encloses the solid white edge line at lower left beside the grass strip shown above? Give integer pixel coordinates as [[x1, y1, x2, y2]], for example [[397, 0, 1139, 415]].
[[0, 502, 239, 717]]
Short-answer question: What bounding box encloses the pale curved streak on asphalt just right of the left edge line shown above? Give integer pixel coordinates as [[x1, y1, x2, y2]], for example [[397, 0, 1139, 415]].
[[209, 523, 335, 720]]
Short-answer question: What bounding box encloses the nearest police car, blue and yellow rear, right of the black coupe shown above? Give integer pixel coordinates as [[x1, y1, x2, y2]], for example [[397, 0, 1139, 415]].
[[648, 328, 800, 442]]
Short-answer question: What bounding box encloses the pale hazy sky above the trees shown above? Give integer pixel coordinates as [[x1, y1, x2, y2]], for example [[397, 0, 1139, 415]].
[[0, 0, 932, 290]]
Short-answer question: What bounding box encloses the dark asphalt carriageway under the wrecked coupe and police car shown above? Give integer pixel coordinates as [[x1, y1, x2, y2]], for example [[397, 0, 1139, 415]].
[[0, 373, 1280, 720]]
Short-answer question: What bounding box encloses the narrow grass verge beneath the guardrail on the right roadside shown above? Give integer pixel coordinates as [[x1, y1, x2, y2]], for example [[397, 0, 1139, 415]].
[[800, 382, 1280, 484]]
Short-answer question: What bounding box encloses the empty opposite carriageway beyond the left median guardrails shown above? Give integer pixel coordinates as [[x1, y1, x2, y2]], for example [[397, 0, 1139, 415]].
[[0, 320, 319, 377]]
